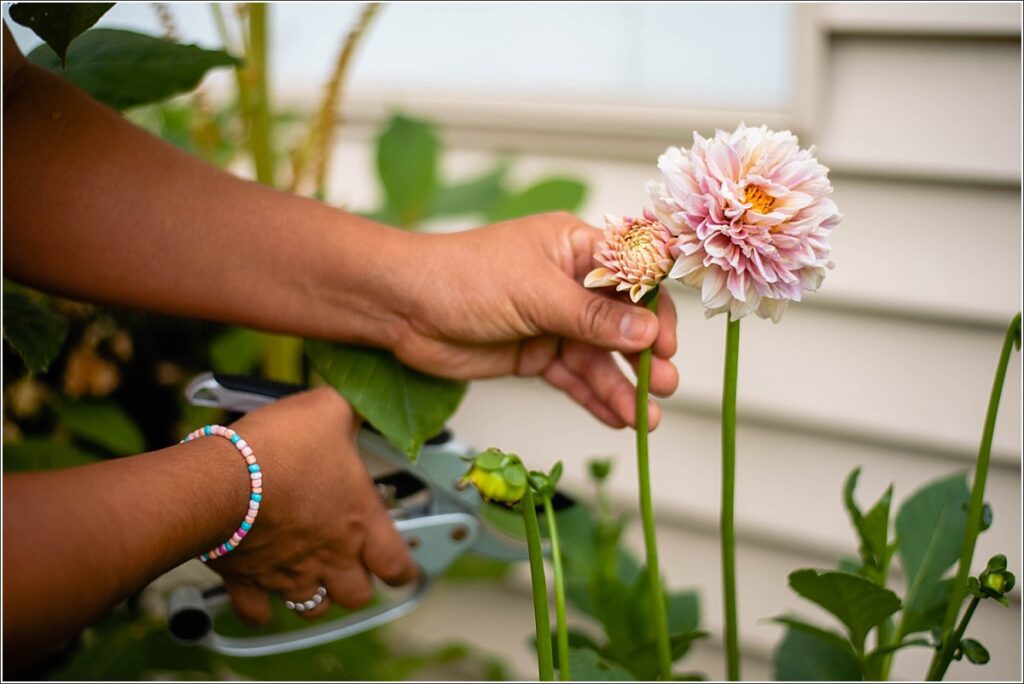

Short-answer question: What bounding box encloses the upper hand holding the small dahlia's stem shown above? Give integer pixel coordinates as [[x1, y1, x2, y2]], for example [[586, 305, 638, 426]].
[[393, 213, 679, 428]]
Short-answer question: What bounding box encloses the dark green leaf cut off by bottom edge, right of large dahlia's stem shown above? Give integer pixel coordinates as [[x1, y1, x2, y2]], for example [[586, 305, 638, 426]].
[[772, 618, 863, 682]]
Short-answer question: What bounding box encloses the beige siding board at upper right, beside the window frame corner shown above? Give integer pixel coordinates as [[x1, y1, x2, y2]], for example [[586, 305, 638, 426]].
[[818, 37, 1021, 183]]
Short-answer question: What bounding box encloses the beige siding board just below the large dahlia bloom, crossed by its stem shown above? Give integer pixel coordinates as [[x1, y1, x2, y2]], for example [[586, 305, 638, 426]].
[[669, 296, 1021, 462]]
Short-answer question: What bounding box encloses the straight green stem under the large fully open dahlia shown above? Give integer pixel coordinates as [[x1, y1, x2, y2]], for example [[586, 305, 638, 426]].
[[721, 319, 739, 681]]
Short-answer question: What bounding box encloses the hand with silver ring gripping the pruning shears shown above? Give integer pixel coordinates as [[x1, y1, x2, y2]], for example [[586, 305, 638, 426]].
[[210, 387, 417, 625]]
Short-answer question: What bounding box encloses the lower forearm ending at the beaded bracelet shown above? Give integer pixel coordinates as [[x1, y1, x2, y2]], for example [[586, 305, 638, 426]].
[[3, 437, 249, 670]]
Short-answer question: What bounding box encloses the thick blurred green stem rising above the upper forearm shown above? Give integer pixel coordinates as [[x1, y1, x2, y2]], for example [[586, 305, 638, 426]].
[[245, 2, 273, 185]]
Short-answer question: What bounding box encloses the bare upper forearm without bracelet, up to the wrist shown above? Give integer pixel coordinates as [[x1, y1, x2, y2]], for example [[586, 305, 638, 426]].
[[3, 58, 411, 346]]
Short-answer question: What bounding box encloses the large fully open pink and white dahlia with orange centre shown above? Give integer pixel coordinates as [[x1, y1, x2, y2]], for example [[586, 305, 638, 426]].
[[647, 124, 842, 323]]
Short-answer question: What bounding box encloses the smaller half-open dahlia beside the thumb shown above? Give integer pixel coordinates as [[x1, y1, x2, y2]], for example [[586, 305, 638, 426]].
[[584, 209, 674, 302]]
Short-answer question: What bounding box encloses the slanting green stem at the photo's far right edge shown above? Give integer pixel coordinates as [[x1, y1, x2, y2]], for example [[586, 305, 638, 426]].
[[928, 313, 1021, 680]]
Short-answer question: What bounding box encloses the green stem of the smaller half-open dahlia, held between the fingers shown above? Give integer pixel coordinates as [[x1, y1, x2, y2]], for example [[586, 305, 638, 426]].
[[636, 289, 672, 681]]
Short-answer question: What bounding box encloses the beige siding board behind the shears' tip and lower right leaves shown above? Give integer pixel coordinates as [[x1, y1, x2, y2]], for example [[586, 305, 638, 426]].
[[452, 380, 1024, 567]]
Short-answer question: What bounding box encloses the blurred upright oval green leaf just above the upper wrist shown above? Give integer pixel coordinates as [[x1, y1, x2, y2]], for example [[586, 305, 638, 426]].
[[377, 115, 440, 227]]
